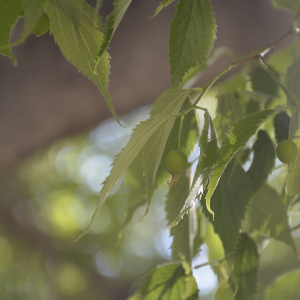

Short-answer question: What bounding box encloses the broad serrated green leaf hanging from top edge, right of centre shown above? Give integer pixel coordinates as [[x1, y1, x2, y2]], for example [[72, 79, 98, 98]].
[[169, 0, 216, 86]]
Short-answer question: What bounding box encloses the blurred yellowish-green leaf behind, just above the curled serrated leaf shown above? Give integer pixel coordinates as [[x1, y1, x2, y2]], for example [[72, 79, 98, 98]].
[[214, 88, 244, 141]]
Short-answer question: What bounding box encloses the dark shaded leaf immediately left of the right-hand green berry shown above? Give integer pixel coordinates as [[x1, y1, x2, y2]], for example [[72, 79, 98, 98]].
[[247, 130, 275, 193]]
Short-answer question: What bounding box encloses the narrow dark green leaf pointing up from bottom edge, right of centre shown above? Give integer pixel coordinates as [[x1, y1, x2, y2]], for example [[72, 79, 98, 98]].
[[231, 233, 259, 300]]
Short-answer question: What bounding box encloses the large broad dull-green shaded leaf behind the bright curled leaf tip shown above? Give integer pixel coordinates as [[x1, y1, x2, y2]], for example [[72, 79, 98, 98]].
[[201, 162, 250, 256]]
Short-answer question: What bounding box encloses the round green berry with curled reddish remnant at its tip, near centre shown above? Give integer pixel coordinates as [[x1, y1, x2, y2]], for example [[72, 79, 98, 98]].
[[164, 150, 188, 176]]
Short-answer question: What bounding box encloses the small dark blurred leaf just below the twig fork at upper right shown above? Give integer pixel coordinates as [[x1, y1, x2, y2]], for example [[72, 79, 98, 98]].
[[251, 67, 278, 96]]
